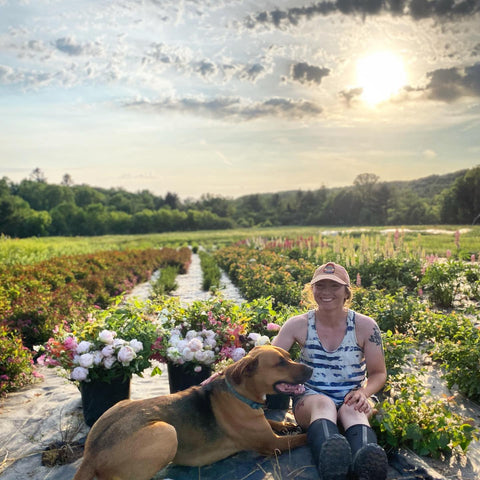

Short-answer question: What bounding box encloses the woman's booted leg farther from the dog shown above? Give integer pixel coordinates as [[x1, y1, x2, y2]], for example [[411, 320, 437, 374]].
[[338, 405, 388, 480]]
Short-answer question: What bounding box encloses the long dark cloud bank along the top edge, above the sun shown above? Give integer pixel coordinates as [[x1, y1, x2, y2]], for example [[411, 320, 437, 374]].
[[245, 0, 480, 28]]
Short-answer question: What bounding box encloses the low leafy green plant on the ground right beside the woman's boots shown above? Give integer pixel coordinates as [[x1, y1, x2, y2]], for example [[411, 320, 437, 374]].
[[371, 375, 476, 457]]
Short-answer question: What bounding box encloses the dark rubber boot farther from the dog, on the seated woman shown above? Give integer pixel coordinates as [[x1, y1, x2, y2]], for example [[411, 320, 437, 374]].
[[345, 424, 388, 480]]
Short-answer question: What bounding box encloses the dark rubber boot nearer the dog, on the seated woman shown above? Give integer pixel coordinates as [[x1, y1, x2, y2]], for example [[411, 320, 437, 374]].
[[307, 418, 352, 480]]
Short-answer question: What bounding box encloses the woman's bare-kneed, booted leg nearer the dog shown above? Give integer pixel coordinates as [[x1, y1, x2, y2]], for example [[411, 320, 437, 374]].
[[294, 395, 352, 480]]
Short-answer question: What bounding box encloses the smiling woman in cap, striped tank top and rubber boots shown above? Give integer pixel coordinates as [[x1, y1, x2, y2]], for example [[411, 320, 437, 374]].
[[272, 262, 388, 480]]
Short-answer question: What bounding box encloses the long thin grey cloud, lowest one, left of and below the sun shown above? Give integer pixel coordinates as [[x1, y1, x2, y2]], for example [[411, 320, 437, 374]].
[[124, 97, 322, 121]]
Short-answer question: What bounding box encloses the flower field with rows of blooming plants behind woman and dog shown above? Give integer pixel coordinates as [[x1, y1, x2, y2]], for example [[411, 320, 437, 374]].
[[0, 228, 480, 456]]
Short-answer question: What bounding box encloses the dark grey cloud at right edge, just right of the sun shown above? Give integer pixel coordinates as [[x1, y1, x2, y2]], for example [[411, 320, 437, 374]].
[[425, 62, 480, 102]]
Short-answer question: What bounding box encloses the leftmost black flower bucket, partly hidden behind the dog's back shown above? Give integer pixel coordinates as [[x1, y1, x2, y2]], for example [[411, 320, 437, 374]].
[[80, 377, 130, 427]]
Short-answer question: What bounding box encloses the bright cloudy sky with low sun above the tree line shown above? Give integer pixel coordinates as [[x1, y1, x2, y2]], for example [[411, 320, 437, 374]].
[[0, 0, 480, 199]]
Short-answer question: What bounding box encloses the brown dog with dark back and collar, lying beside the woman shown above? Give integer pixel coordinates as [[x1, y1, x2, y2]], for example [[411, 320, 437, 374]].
[[74, 345, 312, 480]]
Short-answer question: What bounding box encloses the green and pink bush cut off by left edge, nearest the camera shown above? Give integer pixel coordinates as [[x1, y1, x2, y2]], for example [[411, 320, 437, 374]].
[[0, 325, 34, 397]]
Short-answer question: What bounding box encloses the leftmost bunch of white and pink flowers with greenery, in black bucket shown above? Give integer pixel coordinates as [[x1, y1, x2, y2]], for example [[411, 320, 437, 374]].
[[37, 304, 156, 382]]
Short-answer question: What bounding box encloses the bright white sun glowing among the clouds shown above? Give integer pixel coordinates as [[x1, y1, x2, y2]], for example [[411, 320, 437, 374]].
[[357, 52, 407, 105]]
